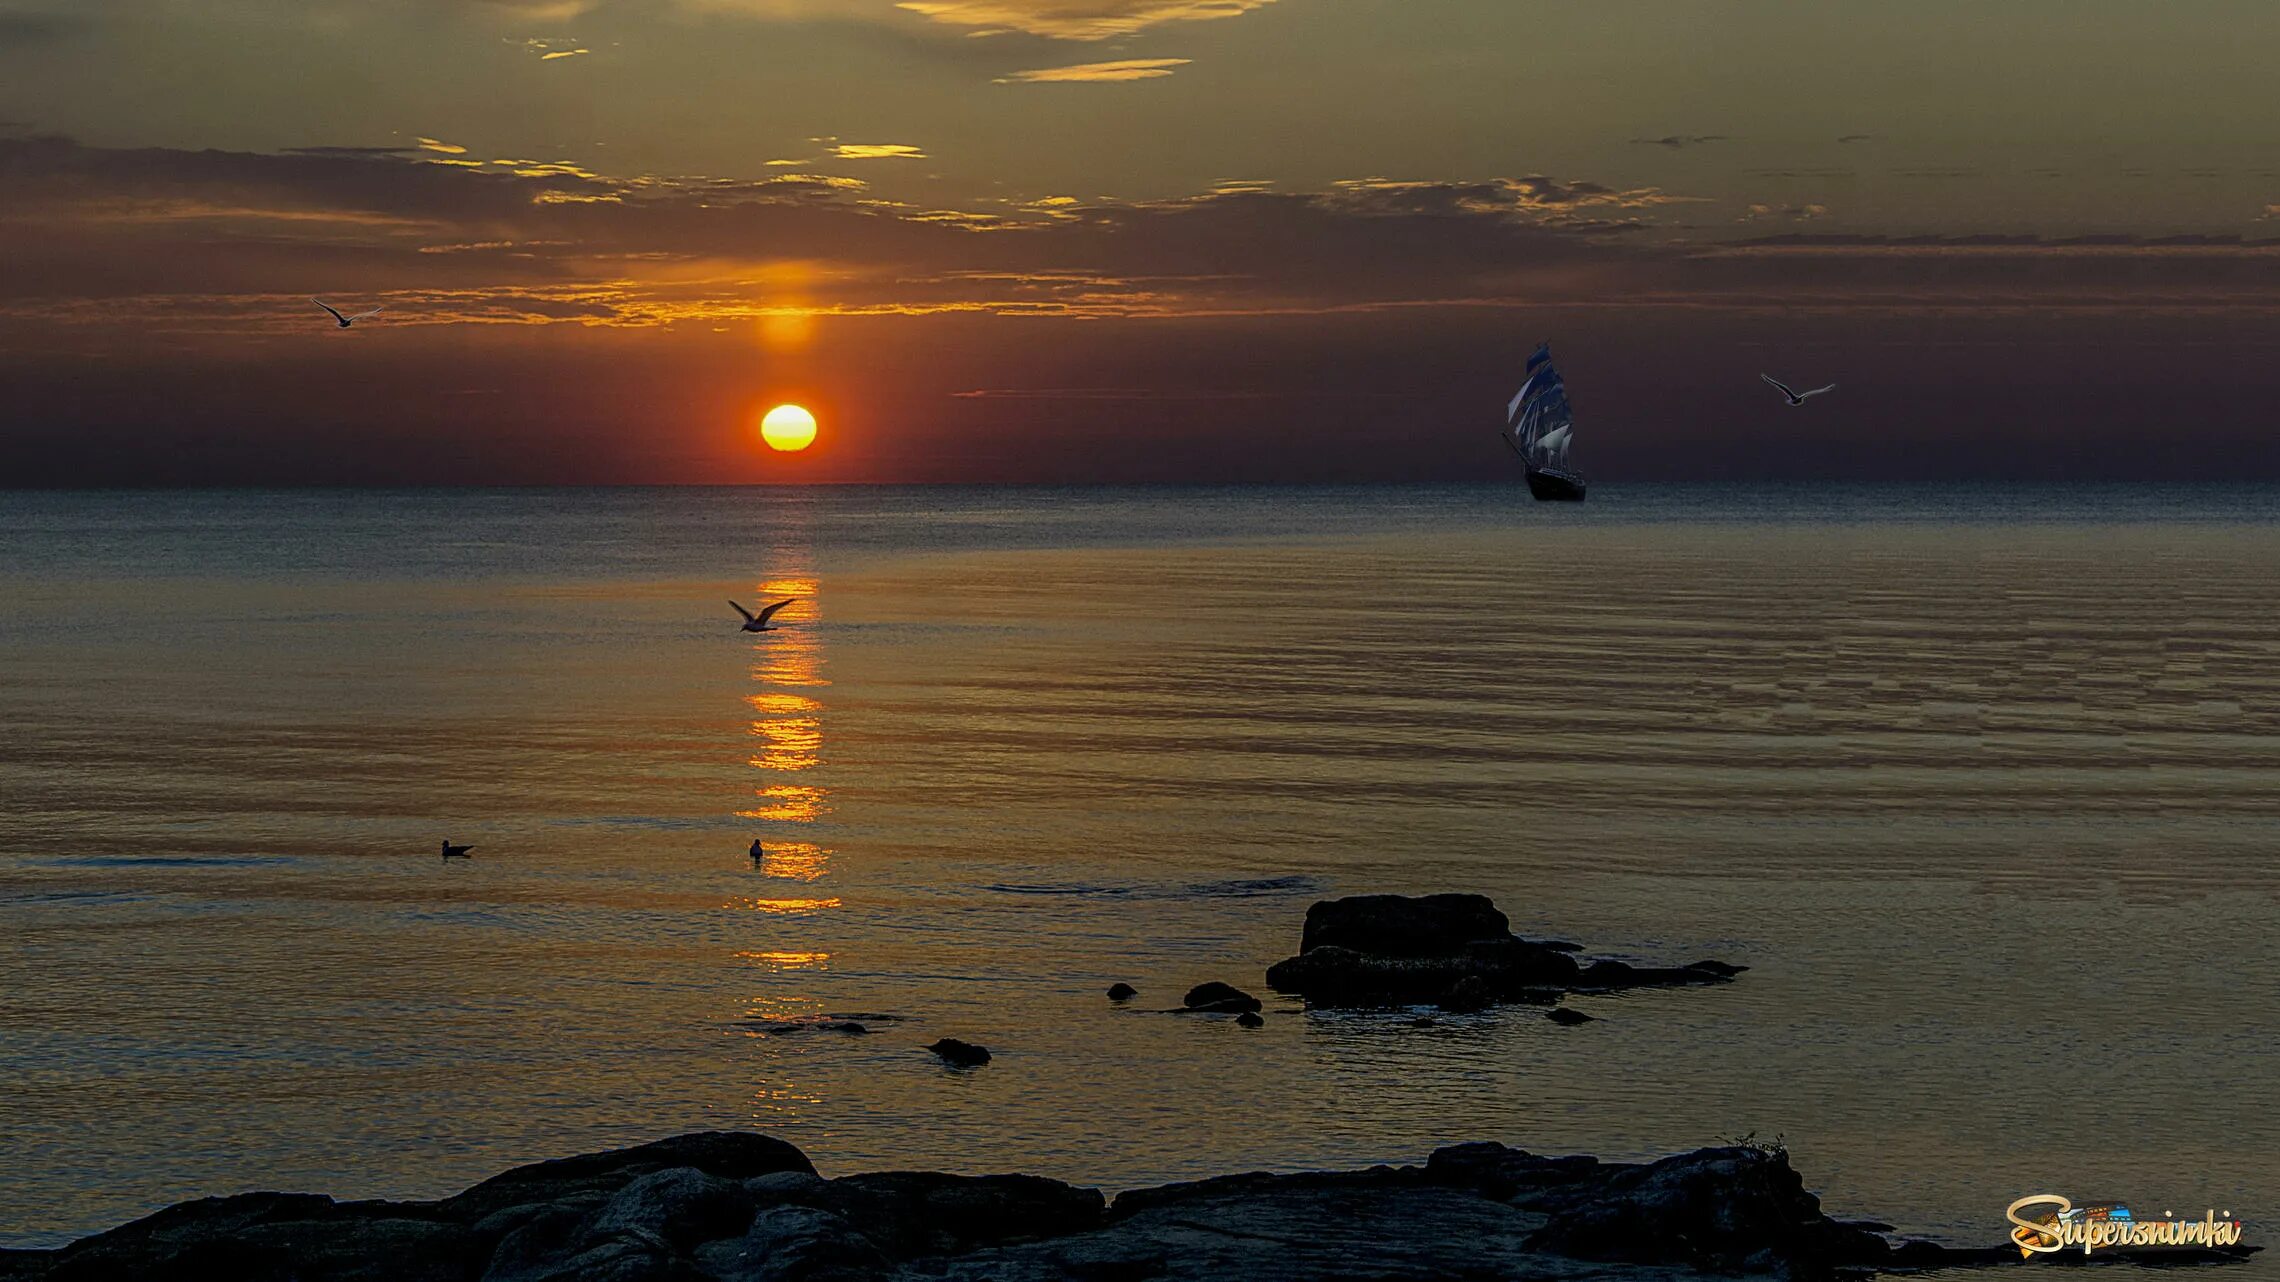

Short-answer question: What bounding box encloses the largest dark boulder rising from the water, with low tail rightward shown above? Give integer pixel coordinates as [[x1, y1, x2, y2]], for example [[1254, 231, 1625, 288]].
[[1268, 894, 1746, 1011]]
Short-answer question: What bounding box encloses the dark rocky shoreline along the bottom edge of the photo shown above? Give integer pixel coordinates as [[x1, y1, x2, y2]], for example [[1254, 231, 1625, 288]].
[[0, 1131, 2052, 1282]]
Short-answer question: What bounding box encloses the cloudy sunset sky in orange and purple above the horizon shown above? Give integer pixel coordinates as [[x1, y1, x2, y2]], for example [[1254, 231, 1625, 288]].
[[0, 0, 2280, 486]]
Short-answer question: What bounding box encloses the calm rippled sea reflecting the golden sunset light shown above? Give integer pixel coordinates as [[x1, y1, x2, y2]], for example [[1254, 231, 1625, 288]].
[[0, 486, 2280, 1277]]
